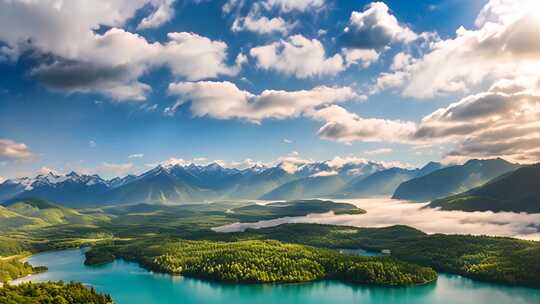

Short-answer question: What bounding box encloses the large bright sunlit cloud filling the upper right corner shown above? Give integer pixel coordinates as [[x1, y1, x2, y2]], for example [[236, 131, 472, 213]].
[[378, 0, 540, 98]]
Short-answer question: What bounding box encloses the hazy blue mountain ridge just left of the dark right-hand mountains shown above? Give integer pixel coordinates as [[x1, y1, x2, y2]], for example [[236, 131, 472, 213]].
[[333, 162, 443, 198]]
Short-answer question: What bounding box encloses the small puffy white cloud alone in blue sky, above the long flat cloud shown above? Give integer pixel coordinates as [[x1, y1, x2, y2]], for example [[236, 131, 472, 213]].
[[249, 35, 346, 78]]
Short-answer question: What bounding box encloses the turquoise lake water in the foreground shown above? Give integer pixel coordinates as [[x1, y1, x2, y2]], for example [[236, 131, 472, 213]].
[[12, 249, 540, 304]]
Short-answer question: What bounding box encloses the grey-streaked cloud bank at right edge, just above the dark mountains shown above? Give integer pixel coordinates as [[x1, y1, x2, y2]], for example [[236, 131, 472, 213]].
[[416, 78, 540, 163]]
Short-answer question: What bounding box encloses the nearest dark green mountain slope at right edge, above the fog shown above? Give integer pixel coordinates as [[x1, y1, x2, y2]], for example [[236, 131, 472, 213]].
[[429, 164, 540, 213]]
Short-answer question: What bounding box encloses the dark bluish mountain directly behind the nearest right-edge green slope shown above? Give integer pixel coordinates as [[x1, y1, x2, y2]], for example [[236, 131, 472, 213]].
[[392, 158, 519, 202]]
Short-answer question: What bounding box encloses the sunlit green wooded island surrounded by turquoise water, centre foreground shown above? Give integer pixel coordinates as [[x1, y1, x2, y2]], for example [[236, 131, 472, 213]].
[[85, 239, 437, 286]]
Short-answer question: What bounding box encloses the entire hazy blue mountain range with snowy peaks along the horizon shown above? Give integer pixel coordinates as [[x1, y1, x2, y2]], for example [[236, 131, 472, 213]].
[[0, 159, 520, 208]]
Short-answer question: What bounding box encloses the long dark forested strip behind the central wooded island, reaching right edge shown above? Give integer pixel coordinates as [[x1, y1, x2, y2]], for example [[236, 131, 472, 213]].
[[213, 224, 540, 288]]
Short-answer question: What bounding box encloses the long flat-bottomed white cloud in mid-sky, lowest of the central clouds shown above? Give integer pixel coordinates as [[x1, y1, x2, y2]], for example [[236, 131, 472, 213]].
[[167, 81, 360, 122]]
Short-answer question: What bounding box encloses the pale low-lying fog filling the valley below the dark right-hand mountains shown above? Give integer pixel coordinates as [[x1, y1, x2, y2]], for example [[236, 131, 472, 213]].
[[214, 198, 540, 240]]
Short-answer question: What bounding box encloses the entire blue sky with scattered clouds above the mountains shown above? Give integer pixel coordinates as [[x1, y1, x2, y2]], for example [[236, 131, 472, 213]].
[[0, 0, 540, 180]]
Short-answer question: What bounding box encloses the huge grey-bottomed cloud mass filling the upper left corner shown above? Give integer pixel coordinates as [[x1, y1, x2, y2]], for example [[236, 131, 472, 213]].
[[0, 0, 245, 100]]
